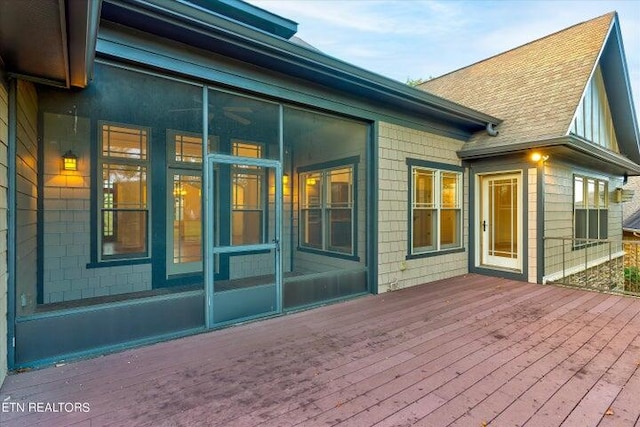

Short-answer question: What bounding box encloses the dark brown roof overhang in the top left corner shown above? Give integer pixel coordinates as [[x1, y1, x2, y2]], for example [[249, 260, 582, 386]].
[[0, 0, 101, 88]]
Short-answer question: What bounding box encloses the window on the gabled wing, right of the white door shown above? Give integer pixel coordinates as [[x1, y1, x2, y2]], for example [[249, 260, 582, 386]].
[[573, 175, 609, 245]]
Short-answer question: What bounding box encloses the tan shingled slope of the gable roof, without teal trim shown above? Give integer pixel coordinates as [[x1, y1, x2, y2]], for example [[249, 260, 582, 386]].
[[419, 12, 616, 148]]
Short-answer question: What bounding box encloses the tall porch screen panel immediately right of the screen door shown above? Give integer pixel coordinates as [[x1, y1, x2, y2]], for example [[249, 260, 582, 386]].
[[282, 106, 370, 309]]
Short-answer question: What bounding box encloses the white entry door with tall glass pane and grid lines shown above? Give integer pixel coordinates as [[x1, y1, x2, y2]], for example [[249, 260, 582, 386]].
[[479, 173, 522, 270]]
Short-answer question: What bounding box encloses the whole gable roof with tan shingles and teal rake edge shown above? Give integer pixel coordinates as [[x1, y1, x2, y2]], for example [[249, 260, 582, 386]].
[[419, 12, 640, 173]]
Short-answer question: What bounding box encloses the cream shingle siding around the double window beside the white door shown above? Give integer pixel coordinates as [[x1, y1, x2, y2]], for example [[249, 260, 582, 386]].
[[378, 122, 469, 292]]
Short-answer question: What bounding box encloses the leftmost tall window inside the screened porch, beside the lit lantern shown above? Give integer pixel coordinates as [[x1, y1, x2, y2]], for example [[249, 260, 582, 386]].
[[98, 123, 149, 260]]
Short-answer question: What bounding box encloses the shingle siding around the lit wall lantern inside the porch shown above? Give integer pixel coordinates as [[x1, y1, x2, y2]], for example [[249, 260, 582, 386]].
[[42, 113, 151, 304]]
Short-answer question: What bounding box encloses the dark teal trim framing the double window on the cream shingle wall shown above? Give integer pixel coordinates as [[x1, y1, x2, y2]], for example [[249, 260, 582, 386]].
[[405, 157, 466, 260]]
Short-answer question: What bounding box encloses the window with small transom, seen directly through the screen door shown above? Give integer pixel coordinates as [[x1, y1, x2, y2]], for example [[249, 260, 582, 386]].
[[231, 141, 266, 245]]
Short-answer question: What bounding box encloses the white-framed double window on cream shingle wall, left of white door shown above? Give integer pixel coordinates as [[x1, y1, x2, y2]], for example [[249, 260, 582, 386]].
[[408, 160, 462, 255]]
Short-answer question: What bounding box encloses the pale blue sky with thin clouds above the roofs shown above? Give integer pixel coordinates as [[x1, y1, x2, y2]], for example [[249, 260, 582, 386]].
[[246, 0, 640, 115]]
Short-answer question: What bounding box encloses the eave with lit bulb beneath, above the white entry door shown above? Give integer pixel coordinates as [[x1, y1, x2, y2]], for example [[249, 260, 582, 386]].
[[458, 135, 640, 176]]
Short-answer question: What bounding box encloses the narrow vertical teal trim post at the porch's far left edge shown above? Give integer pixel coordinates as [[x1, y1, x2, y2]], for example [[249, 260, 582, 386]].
[[7, 79, 18, 369]]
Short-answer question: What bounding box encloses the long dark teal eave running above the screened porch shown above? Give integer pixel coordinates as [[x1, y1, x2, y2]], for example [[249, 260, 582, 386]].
[[102, 0, 501, 136]]
